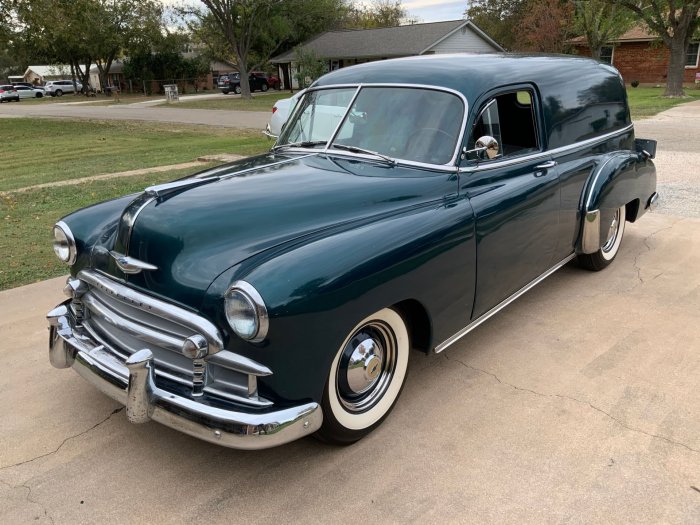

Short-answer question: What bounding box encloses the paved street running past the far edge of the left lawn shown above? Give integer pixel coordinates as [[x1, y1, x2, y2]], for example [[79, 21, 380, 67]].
[[0, 96, 270, 129]]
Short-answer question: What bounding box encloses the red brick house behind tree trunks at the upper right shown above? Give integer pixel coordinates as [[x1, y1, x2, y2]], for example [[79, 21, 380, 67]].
[[569, 26, 700, 84]]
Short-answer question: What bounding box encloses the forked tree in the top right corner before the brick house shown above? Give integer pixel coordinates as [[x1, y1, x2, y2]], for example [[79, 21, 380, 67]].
[[610, 0, 700, 97]]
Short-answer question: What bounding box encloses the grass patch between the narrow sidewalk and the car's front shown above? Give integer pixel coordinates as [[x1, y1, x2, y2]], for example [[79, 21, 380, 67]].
[[0, 164, 219, 290]]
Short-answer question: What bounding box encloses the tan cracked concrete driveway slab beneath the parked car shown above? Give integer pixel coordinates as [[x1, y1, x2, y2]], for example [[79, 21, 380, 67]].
[[0, 104, 700, 524]]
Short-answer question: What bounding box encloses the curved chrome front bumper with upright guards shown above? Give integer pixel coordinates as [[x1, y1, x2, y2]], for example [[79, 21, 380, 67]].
[[47, 301, 323, 450]]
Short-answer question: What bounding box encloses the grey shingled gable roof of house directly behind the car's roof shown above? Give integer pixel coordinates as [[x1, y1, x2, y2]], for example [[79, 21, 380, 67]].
[[271, 20, 503, 64]]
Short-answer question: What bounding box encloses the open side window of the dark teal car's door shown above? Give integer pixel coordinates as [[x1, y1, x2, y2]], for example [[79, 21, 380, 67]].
[[469, 90, 539, 158]]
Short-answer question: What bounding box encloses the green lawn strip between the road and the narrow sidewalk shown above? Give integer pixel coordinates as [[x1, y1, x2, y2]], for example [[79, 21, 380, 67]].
[[0, 119, 270, 191]]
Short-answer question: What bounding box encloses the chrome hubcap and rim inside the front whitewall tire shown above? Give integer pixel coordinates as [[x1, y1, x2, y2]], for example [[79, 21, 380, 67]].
[[336, 323, 396, 412]]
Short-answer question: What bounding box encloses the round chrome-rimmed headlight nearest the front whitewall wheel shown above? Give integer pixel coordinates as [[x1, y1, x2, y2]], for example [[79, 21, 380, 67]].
[[224, 281, 269, 343]]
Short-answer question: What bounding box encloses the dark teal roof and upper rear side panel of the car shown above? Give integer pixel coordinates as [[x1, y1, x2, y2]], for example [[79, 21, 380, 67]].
[[311, 53, 631, 148]]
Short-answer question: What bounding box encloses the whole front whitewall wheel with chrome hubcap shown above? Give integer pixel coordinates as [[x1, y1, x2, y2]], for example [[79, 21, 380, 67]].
[[317, 308, 410, 445]]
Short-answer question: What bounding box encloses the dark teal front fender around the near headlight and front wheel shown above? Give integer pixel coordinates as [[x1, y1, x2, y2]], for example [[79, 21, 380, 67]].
[[204, 199, 476, 401]]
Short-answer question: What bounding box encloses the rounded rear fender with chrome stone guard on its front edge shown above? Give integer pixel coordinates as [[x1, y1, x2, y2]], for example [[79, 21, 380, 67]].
[[576, 151, 656, 253]]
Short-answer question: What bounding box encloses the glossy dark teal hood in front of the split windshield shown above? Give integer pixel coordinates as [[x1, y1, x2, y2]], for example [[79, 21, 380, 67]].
[[101, 154, 456, 308]]
